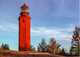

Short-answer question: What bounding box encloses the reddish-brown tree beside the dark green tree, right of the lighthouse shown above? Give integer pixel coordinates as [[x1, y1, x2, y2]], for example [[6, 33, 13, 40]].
[[48, 38, 61, 55]]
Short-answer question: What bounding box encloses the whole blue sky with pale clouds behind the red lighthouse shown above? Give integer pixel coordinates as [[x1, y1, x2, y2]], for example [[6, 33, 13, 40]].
[[0, 0, 80, 50]]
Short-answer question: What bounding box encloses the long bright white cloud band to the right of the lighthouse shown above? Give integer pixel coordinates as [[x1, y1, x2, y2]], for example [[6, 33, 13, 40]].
[[31, 27, 74, 40]]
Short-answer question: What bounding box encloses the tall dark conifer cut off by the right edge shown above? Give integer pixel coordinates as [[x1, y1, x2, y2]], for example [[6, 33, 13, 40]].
[[70, 27, 80, 55]]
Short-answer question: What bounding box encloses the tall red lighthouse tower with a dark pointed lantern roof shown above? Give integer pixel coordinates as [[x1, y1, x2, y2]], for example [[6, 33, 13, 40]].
[[19, 4, 30, 51]]
